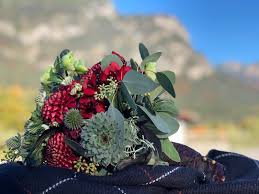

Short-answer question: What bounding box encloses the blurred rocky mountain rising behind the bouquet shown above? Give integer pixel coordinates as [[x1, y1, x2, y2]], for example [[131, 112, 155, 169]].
[[0, 0, 259, 120]]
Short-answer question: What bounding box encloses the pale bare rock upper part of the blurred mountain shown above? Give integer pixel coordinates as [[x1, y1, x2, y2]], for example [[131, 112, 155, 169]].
[[0, 0, 212, 86]]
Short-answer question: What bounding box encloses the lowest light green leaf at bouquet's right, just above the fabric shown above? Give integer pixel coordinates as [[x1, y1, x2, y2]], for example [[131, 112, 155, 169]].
[[160, 139, 181, 162]]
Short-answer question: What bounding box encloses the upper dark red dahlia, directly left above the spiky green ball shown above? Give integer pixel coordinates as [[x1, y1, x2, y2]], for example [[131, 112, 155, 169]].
[[42, 86, 76, 125]]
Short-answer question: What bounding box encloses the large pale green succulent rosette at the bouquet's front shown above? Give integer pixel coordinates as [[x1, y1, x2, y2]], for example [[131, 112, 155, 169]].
[[81, 108, 126, 167]]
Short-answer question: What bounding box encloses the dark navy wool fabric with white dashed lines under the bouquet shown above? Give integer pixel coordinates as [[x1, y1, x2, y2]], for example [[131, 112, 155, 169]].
[[0, 150, 259, 194]]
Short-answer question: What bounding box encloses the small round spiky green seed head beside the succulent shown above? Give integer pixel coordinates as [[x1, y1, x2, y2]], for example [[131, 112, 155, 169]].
[[64, 108, 83, 130]]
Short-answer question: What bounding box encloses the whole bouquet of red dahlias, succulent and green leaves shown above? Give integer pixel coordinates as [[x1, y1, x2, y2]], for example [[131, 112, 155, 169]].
[[6, 43, 180, 175]]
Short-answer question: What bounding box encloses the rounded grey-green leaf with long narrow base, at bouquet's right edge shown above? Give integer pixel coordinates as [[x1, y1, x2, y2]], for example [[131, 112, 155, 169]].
[[138, 106, 179, 135]]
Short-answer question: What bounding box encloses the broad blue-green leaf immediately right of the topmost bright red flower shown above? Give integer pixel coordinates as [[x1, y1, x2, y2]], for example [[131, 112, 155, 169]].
[[123, 70, 158, 94]]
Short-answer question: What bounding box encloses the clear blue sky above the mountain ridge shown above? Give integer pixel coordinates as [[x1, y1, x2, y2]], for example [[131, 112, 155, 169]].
[[113, 0, 259, 65]]
